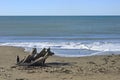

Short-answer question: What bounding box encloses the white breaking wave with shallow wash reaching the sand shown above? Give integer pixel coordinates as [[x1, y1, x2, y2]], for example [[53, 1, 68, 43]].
[[0, 41, 120, 57]]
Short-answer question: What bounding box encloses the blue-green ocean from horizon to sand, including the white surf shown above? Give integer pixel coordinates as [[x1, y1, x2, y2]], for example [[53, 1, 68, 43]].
[[0, 16, 120, 57]]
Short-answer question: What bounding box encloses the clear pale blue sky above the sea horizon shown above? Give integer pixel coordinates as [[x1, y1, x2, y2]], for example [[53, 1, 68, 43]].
[[0, 0, 120, 15]]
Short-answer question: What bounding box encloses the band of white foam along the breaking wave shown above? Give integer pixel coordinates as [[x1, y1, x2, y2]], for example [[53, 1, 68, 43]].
[[0, 42, 120, 51]]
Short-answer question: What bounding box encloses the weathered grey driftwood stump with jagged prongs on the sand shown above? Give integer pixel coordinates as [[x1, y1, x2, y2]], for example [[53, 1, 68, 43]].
[[17, 48, 54, 66]]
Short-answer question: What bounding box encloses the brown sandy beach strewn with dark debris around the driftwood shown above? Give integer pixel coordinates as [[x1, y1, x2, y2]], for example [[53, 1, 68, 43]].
[[0, 46, 120, 80]]
